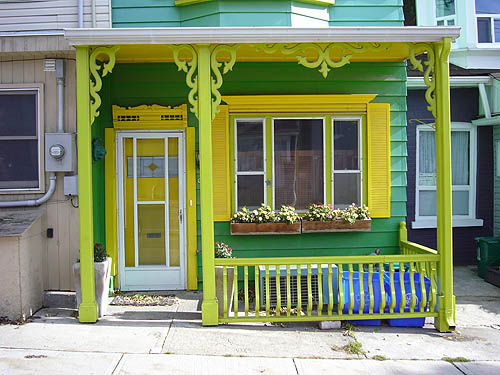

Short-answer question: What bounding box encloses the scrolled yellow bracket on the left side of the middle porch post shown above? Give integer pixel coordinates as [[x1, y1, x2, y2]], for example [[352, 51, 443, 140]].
[[170, 44, 198, 117]]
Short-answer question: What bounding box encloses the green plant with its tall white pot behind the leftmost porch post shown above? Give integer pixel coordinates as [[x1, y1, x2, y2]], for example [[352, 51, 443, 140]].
[[73, 242, 111, 317]]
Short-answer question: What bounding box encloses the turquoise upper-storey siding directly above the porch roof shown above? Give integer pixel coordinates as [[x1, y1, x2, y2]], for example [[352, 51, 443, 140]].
[[112, 0, 403, 27]]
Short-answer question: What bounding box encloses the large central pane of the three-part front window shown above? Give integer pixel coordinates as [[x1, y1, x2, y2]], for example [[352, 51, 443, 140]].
[[274, 119, 324, 210]]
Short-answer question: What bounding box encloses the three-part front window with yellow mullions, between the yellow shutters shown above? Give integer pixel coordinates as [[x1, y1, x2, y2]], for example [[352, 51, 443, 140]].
[[233, 115, 363, 211]]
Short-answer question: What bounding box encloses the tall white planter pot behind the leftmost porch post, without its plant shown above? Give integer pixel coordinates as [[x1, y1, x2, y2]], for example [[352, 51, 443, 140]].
[[73, 257, 111, 318]]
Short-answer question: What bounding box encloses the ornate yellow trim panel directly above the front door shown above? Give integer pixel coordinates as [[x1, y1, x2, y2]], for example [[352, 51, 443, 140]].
[[113, 104, 187, 130]]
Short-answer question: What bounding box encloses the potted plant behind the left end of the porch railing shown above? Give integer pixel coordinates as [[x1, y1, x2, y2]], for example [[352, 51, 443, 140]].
[[215, 241, 237, 317]]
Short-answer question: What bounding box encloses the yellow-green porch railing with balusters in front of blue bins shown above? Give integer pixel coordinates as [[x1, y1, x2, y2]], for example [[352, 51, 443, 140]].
[[215, 226, 440, 323]]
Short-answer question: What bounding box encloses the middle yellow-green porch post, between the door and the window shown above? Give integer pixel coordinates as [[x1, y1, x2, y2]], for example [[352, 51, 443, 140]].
[[197, 44, 218, 326]]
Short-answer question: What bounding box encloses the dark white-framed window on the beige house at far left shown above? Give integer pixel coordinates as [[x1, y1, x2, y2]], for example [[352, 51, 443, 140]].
[[0, 86, 41, 192]]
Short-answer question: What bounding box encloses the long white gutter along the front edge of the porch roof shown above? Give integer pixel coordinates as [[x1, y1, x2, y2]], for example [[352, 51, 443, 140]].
[[64, 26, 460, 46]]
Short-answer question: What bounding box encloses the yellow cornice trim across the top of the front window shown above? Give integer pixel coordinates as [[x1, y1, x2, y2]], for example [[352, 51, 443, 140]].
[[222, 94, 377, 114]]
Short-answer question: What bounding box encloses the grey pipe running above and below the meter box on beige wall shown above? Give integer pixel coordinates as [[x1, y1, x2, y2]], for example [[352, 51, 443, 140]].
[[0, 60, 64, 208]]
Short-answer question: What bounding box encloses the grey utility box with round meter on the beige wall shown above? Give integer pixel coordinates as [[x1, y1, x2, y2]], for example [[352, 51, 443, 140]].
[[45, 133, 76, 172]]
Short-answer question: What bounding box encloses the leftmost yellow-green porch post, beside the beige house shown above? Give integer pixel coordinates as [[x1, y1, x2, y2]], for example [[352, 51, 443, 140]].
[[76, 47, 98, 323]]
